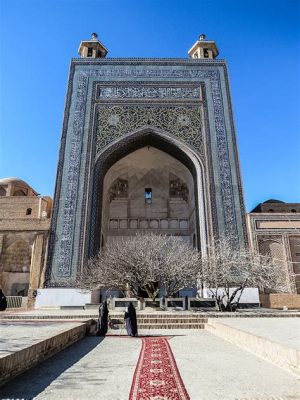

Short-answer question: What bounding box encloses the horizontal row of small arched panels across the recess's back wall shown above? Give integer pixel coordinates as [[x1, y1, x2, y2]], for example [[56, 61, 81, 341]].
[[109, 218, 189, 230]]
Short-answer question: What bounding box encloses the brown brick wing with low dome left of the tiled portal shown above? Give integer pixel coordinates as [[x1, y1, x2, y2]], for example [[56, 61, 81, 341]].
[[0, 178, 52, 306]]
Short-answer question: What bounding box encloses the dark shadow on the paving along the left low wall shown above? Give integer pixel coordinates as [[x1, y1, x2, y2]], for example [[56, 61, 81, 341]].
[[0, 336, 104, 400]]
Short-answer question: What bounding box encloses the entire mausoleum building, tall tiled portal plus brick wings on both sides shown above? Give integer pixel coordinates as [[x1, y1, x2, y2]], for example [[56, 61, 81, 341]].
[[0, 34, 300, 308]]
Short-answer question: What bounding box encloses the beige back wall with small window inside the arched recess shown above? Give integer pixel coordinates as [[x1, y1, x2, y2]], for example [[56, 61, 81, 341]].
[[101, 145, 196, 245]]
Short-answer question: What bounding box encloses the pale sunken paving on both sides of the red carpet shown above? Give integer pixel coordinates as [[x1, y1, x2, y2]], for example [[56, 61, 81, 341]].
[[0, 328, 300, 400]]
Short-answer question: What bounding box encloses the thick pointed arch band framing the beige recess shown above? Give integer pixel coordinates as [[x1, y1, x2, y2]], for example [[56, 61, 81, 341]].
[[86, 126, 207, 257]]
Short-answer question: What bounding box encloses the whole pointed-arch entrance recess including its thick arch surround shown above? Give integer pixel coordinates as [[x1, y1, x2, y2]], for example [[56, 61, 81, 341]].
[[88, 127, 207, 256]]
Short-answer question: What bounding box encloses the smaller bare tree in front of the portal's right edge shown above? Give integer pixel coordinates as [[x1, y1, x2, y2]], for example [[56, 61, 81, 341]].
[[200, 238, 289, 311]]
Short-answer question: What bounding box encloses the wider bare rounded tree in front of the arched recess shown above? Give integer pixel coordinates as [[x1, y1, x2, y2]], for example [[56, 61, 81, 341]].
[[76, 233, 199, 299]]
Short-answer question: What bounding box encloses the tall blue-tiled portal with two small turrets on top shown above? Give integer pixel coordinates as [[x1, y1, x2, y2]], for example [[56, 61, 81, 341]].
[[45, 34, 248, 288]]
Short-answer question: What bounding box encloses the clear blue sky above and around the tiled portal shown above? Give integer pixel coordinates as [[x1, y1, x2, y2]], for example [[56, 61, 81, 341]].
[[0, 0, 300, 211]]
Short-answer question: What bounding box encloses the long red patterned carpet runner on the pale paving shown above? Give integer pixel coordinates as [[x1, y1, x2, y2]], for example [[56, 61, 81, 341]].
[[129, 337, 190, 400]]
